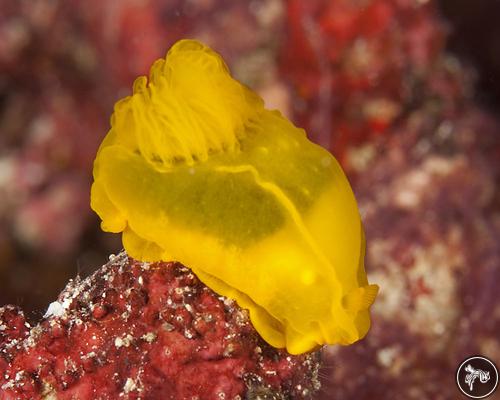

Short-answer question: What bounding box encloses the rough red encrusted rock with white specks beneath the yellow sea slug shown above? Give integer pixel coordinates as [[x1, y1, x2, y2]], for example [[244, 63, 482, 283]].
[[0, 253, 319, 400]]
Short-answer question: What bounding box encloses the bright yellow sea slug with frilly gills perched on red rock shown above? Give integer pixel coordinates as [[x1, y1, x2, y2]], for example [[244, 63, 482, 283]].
[[91, 40, 378, 354]]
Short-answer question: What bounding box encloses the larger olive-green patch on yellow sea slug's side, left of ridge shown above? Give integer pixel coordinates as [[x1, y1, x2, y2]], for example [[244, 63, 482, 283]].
[[143, 162, 285, 246]]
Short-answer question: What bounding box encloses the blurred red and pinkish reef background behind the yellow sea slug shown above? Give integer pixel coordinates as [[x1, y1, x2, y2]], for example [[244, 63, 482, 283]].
[[0, 0, 500, 400]]
